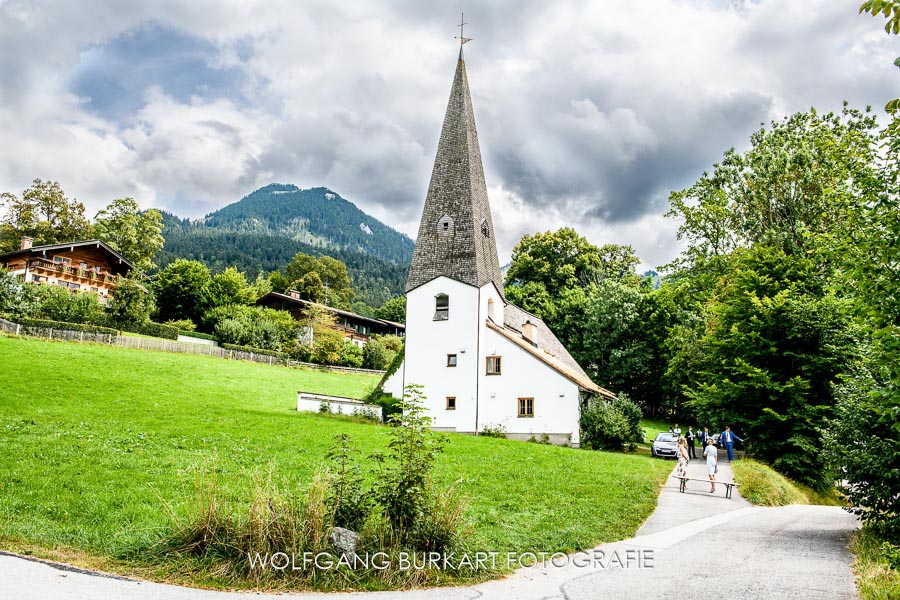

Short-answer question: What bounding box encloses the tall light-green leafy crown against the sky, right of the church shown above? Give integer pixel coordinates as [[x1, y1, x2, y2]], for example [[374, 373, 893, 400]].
[[667, 106, 877, 274]]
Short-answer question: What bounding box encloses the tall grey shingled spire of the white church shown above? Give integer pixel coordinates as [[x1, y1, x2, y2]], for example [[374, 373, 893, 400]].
[[406, 48, 503, 294]]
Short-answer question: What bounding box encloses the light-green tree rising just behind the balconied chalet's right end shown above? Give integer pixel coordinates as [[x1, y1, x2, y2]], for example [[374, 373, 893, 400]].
[[94, 198, 165, 272]]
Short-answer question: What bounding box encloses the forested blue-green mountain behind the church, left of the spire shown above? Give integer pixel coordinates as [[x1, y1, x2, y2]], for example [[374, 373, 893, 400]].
[[155, 184, 414, 307]]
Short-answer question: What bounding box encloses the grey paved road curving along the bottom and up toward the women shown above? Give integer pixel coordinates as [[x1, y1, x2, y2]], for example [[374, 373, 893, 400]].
[[0, 454, 857, 600]]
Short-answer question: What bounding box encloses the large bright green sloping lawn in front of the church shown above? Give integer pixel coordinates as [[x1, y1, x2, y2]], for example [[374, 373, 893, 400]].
[[0, 337, 671, 588]]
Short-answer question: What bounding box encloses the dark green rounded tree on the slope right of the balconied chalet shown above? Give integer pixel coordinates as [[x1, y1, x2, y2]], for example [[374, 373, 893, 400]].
[[153, 259, 212, 323]]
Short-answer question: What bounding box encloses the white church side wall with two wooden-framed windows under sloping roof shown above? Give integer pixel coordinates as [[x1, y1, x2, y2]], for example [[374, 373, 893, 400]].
[[478, 327, 579, 444]]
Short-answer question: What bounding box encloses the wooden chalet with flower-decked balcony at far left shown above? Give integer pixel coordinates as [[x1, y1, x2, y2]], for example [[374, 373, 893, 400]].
[[0, 237, 134, 300]]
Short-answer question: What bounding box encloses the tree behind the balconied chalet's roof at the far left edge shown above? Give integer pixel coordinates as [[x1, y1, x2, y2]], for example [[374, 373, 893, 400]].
[[0, 179, 91, 251]]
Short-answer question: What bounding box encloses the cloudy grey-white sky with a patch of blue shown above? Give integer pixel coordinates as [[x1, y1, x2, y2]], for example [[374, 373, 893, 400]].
[[0, 0, 900, 267]]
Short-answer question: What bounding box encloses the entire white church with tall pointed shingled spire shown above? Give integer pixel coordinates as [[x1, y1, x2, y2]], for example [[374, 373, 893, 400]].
[[384, 47, 614, 446]]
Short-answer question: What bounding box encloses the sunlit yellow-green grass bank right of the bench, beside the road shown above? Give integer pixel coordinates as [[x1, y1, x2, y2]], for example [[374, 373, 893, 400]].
[[731, 458, 844, 506]]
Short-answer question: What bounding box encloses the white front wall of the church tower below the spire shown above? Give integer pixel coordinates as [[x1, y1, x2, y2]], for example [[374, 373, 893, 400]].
[[404, 277, 479, 432]]
